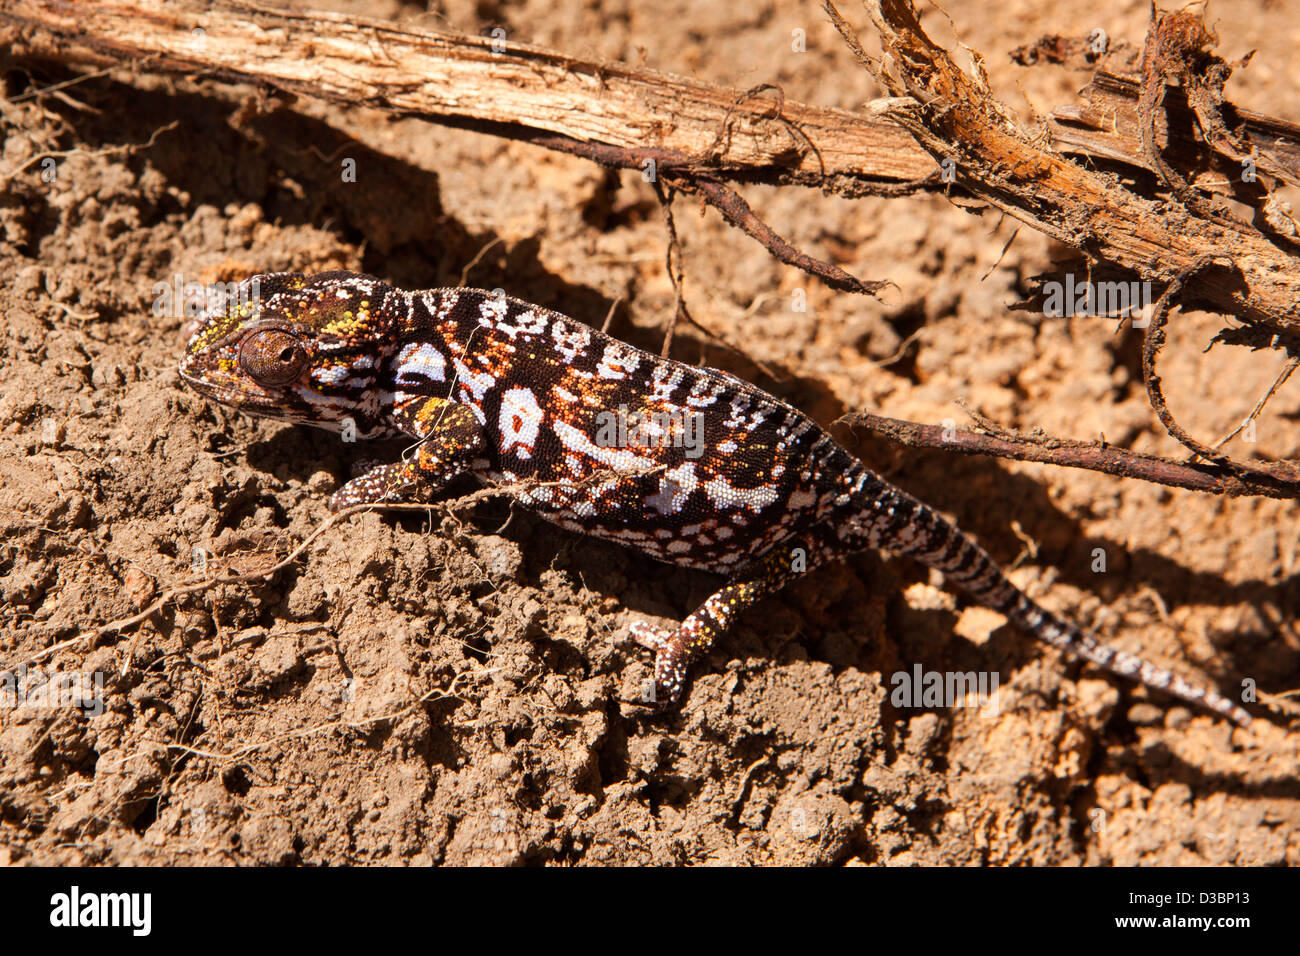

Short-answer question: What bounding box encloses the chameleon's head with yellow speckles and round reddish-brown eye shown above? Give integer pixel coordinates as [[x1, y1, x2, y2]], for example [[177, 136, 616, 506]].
[[179, 272, 390, 437]]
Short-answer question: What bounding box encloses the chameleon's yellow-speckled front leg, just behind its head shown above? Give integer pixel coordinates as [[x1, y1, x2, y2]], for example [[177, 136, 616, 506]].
[[329, 397, 484, 511]]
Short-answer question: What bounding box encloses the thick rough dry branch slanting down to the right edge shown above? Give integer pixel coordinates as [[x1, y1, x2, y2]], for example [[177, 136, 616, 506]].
[[827, 0, 1300, 341]]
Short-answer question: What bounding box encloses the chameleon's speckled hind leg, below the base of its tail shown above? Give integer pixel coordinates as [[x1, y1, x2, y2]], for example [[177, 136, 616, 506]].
[[629, 531, 828, 705]]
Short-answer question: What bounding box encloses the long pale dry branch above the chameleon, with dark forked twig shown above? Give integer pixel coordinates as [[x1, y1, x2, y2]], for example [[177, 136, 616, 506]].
[[0, 0, 933, 294]]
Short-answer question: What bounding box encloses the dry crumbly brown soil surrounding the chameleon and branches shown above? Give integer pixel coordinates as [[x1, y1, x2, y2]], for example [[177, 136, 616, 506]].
[[0, 0, 1300, 865]]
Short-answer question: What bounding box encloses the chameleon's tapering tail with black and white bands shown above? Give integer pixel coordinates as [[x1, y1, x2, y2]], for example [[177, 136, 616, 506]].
[[841, 463, 1251, 727]]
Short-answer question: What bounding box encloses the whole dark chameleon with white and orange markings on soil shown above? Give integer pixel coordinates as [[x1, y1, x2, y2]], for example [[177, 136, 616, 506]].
[[181, 272, 1251, 724]]
